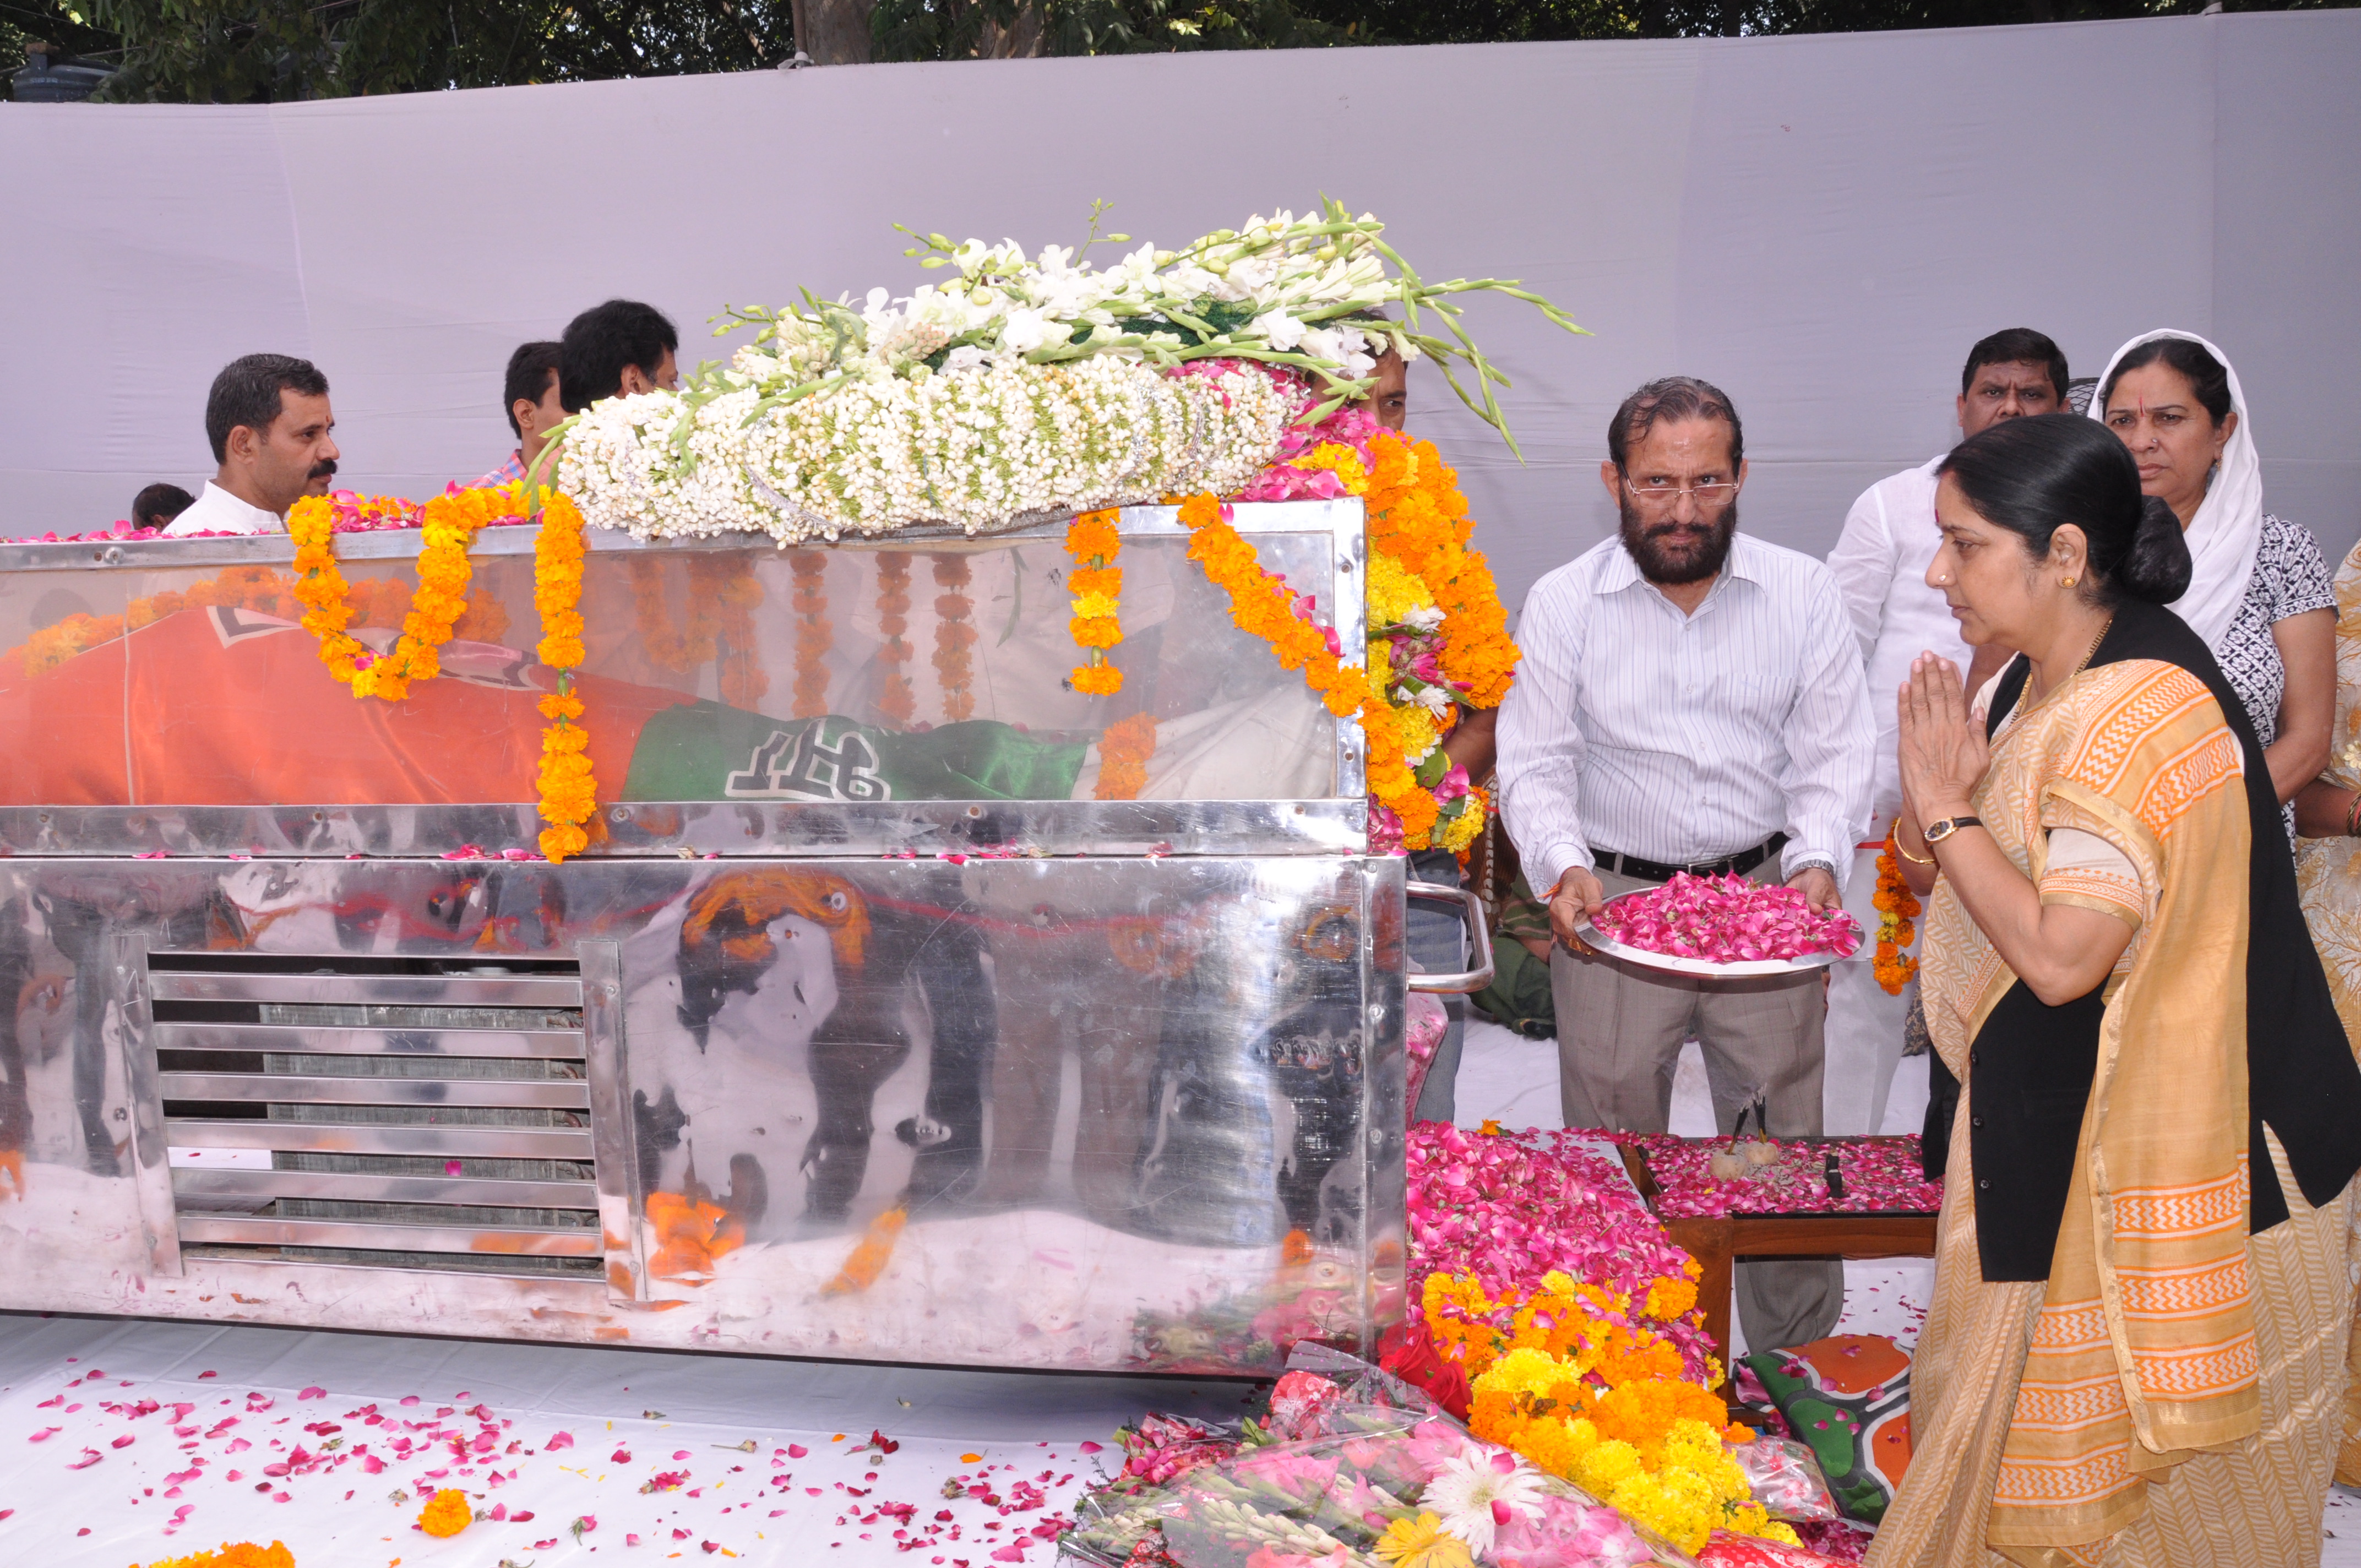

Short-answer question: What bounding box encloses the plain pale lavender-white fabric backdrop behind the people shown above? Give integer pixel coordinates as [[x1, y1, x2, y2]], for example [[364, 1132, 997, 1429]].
[[0, 9, 2361, 607]]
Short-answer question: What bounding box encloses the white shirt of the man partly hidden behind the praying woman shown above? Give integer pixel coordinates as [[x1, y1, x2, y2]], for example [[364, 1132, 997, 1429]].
[[1827, 458, 1976, 824]]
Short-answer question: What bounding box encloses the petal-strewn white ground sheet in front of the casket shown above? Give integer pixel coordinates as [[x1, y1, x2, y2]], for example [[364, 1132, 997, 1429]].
[[0, 1315, 1249, 1568]]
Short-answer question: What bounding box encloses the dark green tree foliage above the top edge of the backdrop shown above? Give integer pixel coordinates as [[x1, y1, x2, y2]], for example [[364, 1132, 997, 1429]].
[[0, 0, 2356, 104]]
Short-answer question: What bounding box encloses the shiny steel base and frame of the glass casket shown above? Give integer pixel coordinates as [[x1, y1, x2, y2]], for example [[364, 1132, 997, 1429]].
[[0, 503, 1487, 1372]]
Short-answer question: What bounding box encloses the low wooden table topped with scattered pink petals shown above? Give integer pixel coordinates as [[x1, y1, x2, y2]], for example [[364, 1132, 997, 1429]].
[[1617, 1134, 1943, 1398]]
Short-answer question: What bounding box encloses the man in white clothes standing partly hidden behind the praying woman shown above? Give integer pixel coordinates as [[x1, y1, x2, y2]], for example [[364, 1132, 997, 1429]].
[[1827, 326, 2068, 1134]]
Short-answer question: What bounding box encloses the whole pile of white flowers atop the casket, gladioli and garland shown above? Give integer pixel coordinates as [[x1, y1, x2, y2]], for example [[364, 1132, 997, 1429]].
[[559, 203, 1580, 541]]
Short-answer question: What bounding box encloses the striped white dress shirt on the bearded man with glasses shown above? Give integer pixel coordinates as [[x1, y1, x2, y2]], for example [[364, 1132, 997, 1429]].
[[1499, 533, 1877, 897]]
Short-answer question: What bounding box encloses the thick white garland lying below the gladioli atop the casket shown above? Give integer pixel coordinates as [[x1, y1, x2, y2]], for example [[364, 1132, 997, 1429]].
[[559, 350, 1301, 543]]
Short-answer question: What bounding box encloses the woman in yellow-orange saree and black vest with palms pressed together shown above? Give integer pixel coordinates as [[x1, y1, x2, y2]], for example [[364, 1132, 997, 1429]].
[[1868, 416, 2361, 1568]]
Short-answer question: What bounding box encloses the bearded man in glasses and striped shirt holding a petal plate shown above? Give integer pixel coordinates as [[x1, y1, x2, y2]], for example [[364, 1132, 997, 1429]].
[[1499, 375, 1877, 1351]]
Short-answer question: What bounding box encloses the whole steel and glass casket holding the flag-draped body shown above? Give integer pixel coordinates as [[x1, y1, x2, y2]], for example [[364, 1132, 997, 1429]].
[[0, 500, 1481, 1372]]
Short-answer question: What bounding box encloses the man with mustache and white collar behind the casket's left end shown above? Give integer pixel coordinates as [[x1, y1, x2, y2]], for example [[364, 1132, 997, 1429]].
[[165, 354, 338, 533]]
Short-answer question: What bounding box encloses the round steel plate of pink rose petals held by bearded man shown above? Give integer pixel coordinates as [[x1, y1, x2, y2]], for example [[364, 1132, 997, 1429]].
[[1582, 872, 1860, 980]]
